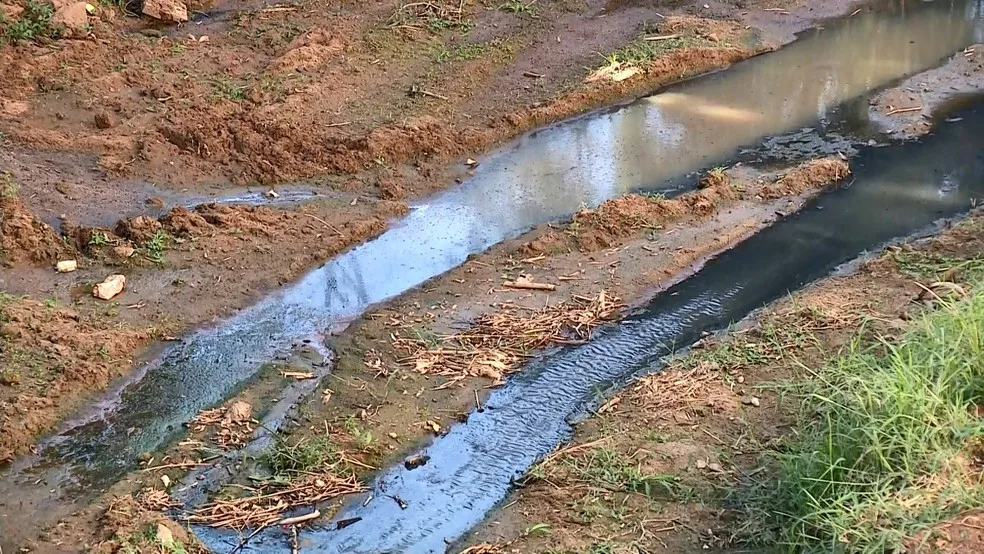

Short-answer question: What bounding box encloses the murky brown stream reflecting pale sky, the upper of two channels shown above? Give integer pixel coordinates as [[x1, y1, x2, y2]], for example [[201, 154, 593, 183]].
[[0, 1, 984, 546]]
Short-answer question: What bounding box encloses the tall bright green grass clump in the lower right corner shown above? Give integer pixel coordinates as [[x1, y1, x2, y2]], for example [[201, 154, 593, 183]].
[[737, 288, 984, 554]]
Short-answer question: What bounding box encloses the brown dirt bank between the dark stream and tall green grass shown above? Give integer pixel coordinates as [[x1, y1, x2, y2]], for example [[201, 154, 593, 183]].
[[460, 215, 984, 554]]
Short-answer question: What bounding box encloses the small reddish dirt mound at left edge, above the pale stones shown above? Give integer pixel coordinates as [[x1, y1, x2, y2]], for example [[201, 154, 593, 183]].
[[0, 195, 70, 265]]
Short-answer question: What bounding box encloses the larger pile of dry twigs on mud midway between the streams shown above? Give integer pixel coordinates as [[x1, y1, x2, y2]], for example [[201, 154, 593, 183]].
[[393, 290, 623, 382]]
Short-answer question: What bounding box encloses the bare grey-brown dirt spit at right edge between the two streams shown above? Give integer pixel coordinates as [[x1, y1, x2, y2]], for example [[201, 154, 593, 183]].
[[870, 44, 984, 138]]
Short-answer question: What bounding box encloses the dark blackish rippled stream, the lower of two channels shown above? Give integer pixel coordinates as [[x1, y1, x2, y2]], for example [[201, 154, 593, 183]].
[[196, 98, 984, 554]]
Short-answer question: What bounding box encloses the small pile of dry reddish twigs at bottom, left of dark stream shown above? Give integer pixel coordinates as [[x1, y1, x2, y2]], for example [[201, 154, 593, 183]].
[[186, 473, 365, 530]]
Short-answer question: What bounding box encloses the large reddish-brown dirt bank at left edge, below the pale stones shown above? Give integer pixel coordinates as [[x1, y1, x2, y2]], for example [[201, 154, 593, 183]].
[[0, 296, 152, 462]]
